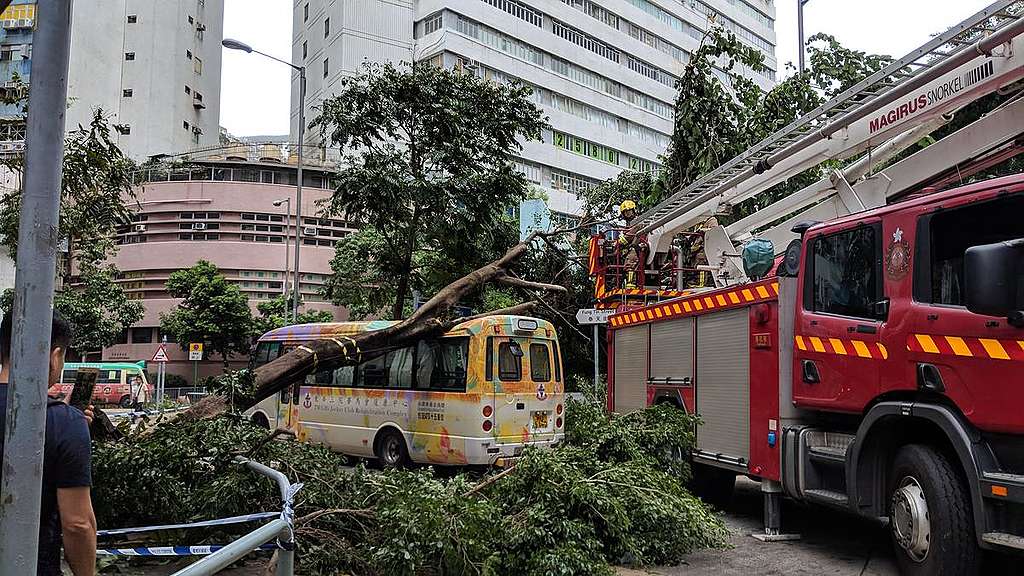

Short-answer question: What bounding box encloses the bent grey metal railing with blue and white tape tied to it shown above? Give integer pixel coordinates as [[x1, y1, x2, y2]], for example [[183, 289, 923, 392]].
[[96, 456, 302, 576]]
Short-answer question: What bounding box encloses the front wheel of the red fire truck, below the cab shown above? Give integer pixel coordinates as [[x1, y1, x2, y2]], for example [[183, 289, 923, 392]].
[[889, 444, 981, 576]]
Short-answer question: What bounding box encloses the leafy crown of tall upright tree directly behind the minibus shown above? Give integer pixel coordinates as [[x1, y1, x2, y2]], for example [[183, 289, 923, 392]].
[[312, 64, 545, 319]]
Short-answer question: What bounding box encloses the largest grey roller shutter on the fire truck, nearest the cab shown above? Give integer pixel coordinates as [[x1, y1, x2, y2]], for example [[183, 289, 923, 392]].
[[696, 307, 751, 463]]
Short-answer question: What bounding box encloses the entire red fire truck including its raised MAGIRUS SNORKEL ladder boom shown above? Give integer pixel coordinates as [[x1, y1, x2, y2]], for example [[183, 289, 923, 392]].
[[592, 1, 1024, 575]]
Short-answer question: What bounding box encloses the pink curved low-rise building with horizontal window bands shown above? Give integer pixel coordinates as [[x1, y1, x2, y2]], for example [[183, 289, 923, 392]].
[[102, 156, 354, 381]]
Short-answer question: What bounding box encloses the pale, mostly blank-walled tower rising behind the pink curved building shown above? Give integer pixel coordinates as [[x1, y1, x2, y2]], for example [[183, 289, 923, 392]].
[[67, 0, 224, 160]]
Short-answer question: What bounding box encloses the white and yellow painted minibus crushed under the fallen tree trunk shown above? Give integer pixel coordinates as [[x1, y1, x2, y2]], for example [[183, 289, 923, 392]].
[[247, 316, 564, 466]]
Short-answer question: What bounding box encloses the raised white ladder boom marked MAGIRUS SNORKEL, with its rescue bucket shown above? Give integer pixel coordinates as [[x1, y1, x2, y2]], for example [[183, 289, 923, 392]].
[[591, 0, 1024, 295]]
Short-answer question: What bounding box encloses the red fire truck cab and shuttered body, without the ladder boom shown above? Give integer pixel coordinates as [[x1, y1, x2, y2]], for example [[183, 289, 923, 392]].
[[608, 175, 1024, 574]]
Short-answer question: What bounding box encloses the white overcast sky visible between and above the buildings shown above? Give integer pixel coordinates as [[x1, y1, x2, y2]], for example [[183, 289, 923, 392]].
[[220, 0, 990, 136]]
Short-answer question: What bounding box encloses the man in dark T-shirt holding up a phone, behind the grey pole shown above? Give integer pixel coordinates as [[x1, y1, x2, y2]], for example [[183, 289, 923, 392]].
[[0, 312, 96, 576]]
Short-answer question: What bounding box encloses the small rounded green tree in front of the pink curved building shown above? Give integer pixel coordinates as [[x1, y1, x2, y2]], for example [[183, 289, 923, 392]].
[[160, 260, 255, 366]]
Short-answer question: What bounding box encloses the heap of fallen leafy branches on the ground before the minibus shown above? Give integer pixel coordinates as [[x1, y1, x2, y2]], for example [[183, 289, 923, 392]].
[[93, 402, 727, 576]]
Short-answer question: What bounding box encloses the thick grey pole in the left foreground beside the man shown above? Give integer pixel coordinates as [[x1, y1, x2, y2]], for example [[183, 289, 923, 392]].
[[0, 0, 71, 576]]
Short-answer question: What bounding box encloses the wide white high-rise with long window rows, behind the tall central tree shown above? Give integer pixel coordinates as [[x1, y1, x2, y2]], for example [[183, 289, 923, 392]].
[[292, 0, 777, 217]]
